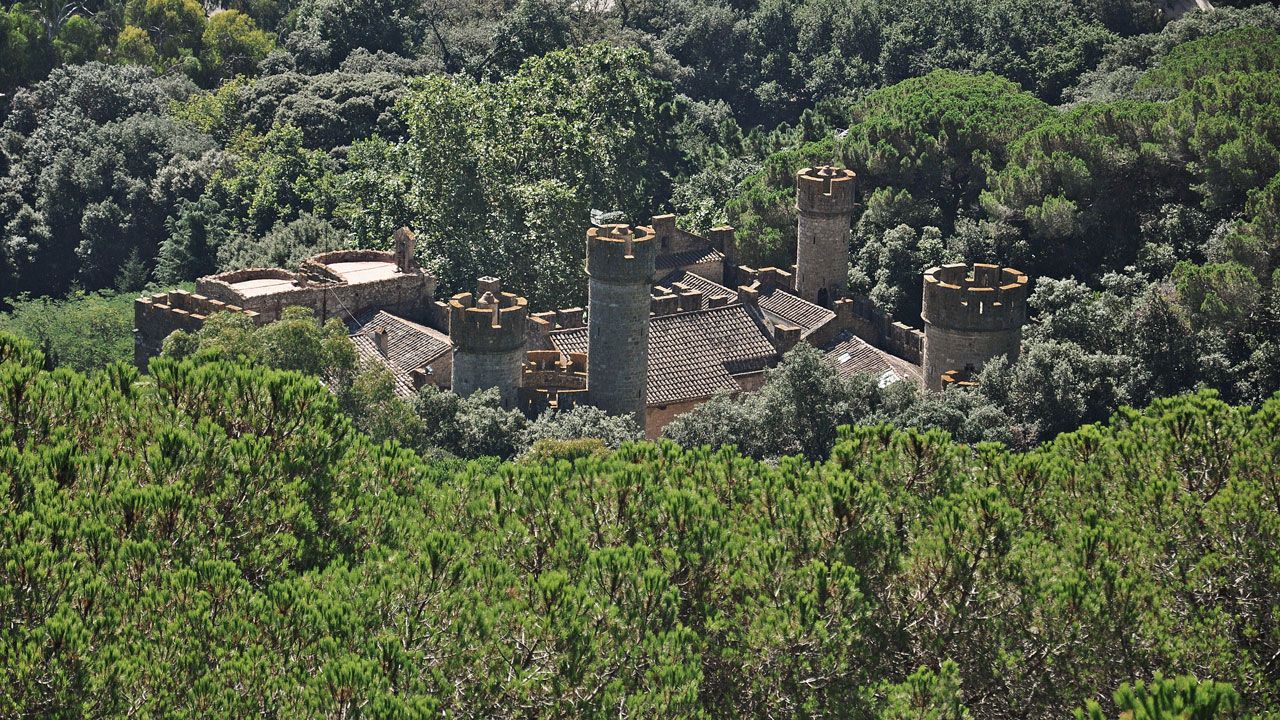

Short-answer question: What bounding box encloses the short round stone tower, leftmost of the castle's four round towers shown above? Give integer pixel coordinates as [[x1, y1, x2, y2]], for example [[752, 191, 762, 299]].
[[449, 278, 529, 409]]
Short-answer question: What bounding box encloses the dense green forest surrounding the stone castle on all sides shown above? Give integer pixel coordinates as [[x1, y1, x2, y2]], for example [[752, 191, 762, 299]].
[[0, 0, 1280, 707]]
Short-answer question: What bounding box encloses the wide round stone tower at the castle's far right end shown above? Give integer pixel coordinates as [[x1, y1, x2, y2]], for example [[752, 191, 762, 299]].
[[920, 263, 1028, 391]]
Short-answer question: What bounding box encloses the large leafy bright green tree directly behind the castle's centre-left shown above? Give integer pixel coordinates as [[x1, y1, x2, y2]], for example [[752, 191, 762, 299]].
[[339, 45, 675, 306]]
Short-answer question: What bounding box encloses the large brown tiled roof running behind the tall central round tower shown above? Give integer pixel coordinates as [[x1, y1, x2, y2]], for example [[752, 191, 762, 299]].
[[550, 305, 778, 405]]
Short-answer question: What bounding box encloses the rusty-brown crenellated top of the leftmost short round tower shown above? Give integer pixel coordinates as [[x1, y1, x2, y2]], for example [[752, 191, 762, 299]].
[[449, 278, 529, 352]]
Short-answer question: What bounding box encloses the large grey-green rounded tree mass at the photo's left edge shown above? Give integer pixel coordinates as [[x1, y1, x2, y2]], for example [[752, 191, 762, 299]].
[[0, 63, 209, 296]]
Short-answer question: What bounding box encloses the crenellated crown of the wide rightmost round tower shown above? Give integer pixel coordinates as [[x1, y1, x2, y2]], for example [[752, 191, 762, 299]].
[[920, 263, 1029, 331]]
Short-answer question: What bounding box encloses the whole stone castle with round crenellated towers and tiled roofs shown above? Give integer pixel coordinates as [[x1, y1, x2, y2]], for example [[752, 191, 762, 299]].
[[134, 167, 1028, 437]]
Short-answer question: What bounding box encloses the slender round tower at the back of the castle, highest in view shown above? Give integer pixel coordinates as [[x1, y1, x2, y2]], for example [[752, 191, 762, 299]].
[[795, 165, 858, 307]]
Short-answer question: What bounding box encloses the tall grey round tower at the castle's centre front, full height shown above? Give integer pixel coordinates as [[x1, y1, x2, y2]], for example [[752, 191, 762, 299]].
[[586, 225, 658, 428]]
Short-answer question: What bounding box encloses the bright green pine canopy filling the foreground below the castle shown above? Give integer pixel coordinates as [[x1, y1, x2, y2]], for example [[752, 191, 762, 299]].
[[0, 333, 1280, 720]]
